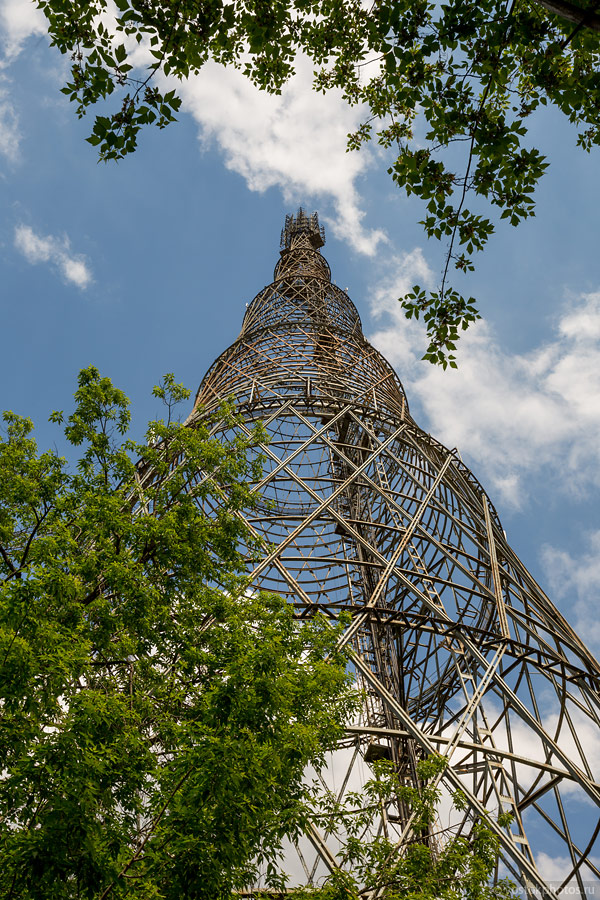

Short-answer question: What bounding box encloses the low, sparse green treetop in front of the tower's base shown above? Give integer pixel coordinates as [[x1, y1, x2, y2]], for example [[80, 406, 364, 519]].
[[278, 756, 517, 900]]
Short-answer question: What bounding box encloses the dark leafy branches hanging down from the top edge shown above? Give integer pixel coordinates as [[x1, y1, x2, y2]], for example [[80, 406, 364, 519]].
[[37, 0, 600, 367]]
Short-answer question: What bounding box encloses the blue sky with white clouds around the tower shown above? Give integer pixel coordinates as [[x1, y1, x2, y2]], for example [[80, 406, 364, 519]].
[[0, 0, 600, 676]]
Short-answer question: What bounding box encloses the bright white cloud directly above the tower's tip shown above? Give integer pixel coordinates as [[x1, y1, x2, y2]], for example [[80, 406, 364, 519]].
[[177, 59, 386, 256]]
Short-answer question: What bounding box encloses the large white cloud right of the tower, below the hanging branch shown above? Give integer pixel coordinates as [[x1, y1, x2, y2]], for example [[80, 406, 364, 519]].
[[371, 268, 600, 507]]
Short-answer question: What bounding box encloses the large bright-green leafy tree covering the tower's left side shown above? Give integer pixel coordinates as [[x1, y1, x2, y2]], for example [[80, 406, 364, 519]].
[[0, 368, 353, 900]]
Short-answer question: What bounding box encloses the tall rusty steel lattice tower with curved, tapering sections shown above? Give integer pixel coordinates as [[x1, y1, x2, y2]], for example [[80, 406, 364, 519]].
[[190, 210, 600, 897]]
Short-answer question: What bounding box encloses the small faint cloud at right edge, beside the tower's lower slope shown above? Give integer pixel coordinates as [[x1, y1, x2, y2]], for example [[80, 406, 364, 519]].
[[541, 531, 600, 651]]
